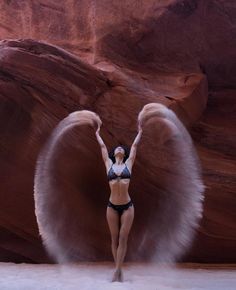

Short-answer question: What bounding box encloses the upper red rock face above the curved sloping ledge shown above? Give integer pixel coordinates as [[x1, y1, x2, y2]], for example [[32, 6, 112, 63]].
[[0, 0, 236, 86]]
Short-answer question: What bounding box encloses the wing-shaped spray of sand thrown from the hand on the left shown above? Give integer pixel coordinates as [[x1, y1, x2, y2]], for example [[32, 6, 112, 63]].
[[34, 110, 101, 263]]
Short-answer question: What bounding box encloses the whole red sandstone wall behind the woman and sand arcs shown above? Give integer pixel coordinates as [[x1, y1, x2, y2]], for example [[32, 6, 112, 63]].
[[0, 0, 236, 262]]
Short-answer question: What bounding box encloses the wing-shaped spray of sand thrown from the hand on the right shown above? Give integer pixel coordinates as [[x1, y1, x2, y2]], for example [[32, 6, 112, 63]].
[[137, 103, 205, 262]]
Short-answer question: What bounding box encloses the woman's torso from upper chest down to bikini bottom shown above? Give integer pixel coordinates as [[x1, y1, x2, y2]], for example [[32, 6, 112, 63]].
[[107, 163, 131, 204]]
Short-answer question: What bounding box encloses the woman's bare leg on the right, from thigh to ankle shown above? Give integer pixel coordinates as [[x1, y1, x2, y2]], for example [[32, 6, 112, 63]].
[[116, 206, 134, 271]]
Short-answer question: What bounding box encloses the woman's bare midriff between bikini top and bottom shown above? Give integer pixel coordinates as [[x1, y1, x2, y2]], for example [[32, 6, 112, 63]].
[[109, 179, 130, 205]]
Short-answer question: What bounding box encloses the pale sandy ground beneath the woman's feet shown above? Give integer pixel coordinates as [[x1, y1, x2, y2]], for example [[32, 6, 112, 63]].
[[0, 262, 236, 290]]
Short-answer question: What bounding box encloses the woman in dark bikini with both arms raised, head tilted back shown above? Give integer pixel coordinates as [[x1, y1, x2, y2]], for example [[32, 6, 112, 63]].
[[96, 126, 142, 282]]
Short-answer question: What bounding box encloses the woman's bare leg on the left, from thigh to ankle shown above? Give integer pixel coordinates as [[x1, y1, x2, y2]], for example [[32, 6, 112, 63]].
[[106, 207, 120, 263]]
